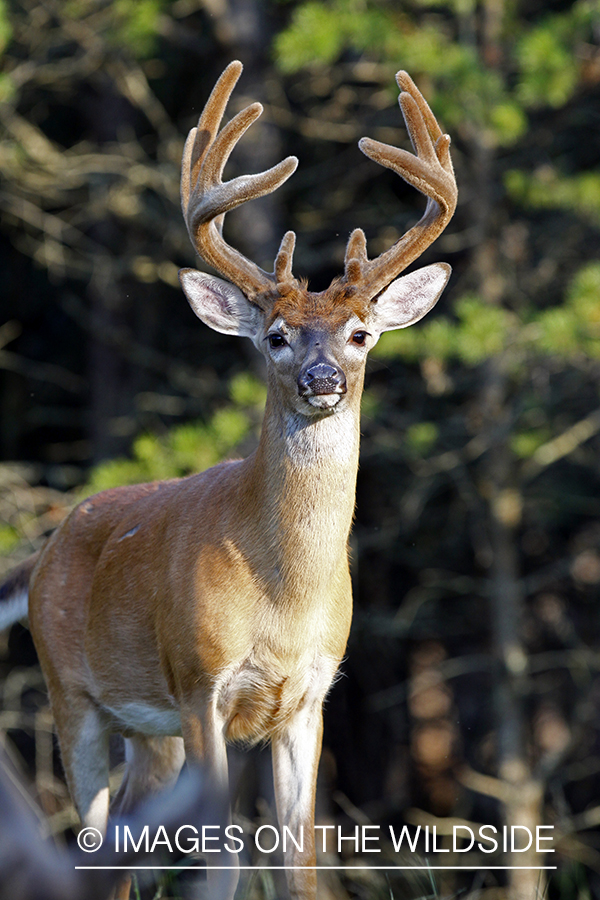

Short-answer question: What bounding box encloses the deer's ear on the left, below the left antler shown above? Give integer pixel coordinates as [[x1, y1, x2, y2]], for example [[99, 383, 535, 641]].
[[179, 269, 261, 340]]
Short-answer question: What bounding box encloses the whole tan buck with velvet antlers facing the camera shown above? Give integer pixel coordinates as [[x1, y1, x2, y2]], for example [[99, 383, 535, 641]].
[[0, 61, 457, 900]]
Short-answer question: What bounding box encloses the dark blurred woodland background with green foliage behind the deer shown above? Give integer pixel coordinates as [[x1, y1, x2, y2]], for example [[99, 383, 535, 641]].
[[0, 0, 600, 900]]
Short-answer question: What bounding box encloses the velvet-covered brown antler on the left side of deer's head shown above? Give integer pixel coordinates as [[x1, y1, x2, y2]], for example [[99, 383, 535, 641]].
[[181, 60, 298, 309]]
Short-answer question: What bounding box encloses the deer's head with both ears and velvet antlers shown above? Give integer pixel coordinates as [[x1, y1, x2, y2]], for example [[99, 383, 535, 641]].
[[180, 62, 457, 416]]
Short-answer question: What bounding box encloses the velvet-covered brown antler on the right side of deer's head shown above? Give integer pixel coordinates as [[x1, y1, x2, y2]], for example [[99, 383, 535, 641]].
[[345, 71, 457, 297]]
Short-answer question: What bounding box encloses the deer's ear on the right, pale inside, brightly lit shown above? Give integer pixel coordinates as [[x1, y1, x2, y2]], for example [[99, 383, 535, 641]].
[[373, 263, 452, 334]]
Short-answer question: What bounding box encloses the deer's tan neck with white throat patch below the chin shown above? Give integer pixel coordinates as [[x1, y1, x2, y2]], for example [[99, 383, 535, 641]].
[[245, 388, 360, 595]]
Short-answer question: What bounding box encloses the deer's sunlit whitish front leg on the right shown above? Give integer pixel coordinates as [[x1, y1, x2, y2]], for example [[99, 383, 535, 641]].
[[273, 700, 323, 900]]
